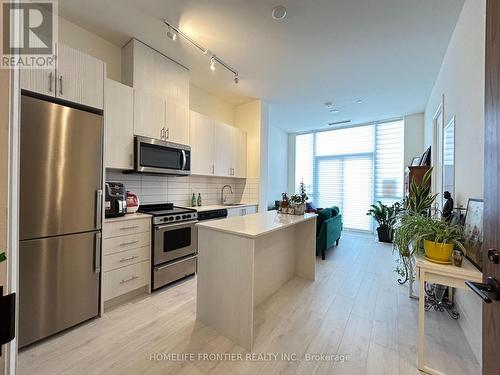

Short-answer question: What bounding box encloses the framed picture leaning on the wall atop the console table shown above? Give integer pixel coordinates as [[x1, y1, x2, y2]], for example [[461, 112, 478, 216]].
[[464, 198, 484, 270]]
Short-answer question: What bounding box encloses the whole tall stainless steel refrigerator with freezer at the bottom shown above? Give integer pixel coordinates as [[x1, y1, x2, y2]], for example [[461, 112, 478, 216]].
[[19, 94, 103, 347]]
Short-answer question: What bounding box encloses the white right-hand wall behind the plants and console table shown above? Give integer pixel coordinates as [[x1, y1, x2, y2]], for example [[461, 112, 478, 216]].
[[425, 0, 486, 361]]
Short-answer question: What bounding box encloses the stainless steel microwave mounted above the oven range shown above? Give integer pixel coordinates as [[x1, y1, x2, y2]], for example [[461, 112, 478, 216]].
[[134, 136, 191, 176]]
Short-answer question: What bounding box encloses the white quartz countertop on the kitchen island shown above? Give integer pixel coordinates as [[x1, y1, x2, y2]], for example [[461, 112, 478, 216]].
[[197, 211, 317, 238]]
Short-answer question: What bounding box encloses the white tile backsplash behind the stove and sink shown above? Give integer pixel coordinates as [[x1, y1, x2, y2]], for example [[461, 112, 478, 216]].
[[106, 170, 259, 206]]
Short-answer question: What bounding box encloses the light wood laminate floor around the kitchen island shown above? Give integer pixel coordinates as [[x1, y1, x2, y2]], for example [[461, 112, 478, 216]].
[[18, 232, 480, 375]]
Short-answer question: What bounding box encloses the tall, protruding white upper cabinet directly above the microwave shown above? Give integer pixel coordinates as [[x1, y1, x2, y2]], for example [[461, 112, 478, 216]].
[[122, 39, 190, 144]]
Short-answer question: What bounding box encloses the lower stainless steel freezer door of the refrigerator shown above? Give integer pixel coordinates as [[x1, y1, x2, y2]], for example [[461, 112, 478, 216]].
[[19, 232, 100, 347]]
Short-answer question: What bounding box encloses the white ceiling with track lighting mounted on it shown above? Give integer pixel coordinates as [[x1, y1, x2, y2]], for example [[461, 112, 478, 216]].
[[59, 0, 464, 131]]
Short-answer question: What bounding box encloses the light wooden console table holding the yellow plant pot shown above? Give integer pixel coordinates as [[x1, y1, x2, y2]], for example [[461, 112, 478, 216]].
[[416, 257, 483, 375]]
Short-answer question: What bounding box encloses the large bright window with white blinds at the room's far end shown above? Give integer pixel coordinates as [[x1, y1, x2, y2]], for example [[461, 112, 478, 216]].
[[295, 120, 404, 231]]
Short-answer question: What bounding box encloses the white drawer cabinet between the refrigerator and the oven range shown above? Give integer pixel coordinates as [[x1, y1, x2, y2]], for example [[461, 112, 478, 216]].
[[102, 215, 151, 301]]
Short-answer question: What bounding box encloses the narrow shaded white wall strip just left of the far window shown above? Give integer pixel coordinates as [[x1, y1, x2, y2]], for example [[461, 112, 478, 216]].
[[267, 126, 288, 207]]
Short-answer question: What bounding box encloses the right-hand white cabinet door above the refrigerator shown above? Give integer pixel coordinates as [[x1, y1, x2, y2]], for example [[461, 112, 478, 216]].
[[56, 44, 104, 109]]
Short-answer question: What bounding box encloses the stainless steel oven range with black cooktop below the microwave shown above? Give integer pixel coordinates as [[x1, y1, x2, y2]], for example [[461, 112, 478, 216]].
[[138, 203, 198, 291]]
